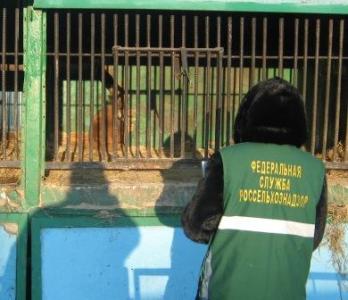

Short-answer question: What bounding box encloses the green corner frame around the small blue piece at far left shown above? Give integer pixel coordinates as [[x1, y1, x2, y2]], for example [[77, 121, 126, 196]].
[[0, 213, 28, 300]]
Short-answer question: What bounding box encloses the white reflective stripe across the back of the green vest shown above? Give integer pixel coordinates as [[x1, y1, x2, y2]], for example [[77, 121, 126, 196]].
[[219, 216, 315, 238]]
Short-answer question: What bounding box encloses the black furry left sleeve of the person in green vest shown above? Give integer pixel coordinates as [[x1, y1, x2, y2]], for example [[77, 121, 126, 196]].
[[181, 152, 223, 243]]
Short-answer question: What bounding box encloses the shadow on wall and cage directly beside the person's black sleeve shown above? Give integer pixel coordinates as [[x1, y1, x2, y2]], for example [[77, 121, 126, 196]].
[[155, 132, 207, 300]]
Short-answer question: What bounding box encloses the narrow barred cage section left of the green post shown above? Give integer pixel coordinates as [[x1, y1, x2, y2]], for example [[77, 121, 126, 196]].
[[0, 5, 24, 168]]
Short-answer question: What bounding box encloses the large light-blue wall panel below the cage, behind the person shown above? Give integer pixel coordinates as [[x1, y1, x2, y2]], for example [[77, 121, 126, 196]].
[[41, 226, 348, 300]]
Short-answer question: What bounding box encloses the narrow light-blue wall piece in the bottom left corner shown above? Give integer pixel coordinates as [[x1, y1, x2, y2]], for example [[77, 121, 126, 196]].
[[0, 224, 17, 300]]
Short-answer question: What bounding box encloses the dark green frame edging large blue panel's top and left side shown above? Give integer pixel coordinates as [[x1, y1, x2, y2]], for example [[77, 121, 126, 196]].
[[31, 210, 181, 300]]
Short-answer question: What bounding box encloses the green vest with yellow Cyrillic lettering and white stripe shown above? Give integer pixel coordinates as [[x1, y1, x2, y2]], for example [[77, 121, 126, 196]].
[[199, 143, 325, 300]]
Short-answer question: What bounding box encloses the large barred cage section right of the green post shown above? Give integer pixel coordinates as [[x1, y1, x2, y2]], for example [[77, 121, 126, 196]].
[[46, 10, 348, 169]]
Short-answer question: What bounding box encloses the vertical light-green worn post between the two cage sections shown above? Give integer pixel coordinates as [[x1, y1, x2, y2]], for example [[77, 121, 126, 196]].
[[22, 7, 46, 209]]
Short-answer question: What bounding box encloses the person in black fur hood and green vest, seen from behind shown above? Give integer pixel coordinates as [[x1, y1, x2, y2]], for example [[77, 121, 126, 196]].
[[182, 78, 327, 300]]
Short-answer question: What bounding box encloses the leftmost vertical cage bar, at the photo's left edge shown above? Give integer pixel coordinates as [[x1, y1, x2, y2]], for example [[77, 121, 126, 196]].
[[1, 7, 7, 160]]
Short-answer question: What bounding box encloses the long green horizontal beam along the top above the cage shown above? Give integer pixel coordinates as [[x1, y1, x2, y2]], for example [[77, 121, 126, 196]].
[[34, 0, 348, 14]]
